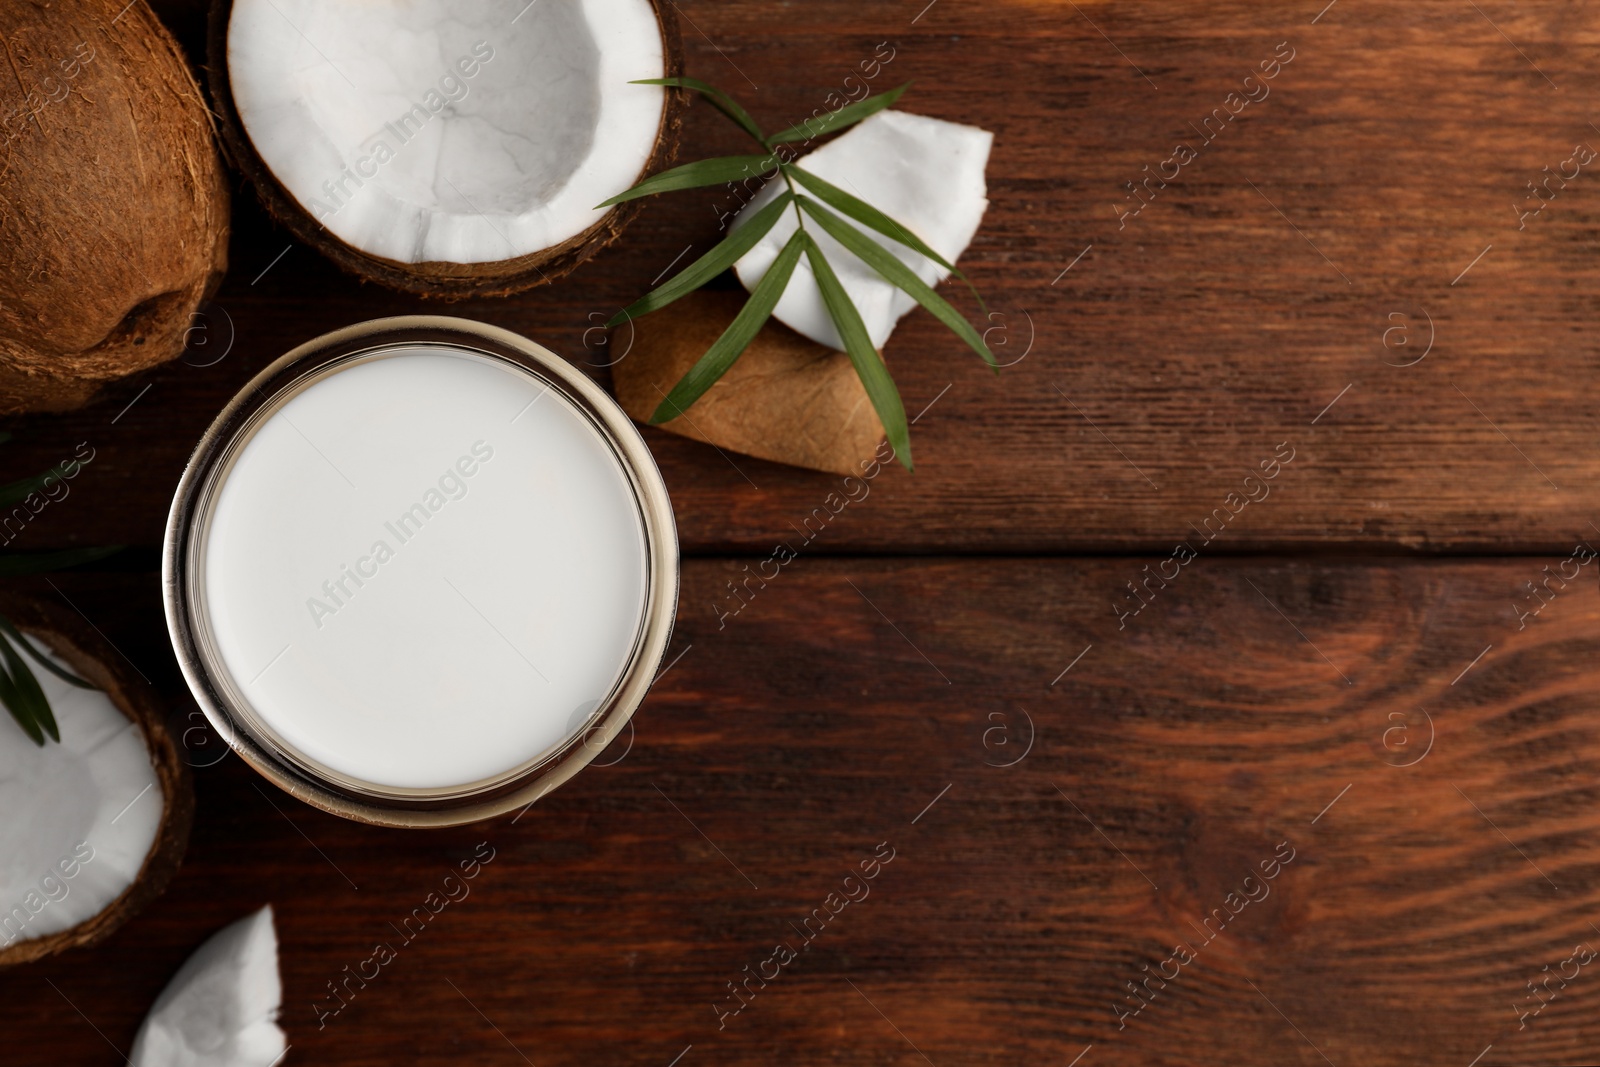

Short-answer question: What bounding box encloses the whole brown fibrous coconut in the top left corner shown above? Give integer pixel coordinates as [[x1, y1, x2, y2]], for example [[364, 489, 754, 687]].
[[0, 0, 227, 414]]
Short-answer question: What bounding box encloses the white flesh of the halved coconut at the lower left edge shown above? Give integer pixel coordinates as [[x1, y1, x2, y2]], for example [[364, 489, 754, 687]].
[[0, 637, 165, 949]]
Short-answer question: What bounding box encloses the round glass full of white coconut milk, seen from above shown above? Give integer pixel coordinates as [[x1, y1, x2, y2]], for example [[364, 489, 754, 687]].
[[163, 317, 678, 825]]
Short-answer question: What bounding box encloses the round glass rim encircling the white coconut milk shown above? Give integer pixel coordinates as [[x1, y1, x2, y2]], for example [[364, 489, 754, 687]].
[[162, 315, 678, 827]]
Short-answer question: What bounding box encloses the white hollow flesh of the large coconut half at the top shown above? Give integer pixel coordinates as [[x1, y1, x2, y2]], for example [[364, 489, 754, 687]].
[[227, 0, 666, 264]]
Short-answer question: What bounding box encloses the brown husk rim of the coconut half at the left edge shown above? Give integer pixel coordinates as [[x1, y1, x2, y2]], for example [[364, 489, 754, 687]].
[[0, 592, 195, 968]]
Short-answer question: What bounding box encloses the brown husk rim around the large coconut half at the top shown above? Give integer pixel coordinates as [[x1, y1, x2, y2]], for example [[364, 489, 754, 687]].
[[206, 0, 688, 301]]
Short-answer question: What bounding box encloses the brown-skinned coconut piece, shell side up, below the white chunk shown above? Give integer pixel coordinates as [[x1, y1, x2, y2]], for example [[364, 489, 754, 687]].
[[611, 290, 883, 474]]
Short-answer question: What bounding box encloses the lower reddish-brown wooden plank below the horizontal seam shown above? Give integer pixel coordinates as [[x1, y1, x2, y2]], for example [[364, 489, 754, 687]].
[[0, 558, 1600, 1067]]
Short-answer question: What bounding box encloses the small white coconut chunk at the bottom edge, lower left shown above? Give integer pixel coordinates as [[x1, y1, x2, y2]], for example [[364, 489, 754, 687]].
[[131, 904, 286, 1067]]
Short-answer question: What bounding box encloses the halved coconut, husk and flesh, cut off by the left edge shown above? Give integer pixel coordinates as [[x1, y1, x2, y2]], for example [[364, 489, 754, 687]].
[[0, 597, 194, 966]]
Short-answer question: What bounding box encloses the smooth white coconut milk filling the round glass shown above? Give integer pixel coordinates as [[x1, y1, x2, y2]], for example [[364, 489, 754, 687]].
[[202, 344, 646, 790]]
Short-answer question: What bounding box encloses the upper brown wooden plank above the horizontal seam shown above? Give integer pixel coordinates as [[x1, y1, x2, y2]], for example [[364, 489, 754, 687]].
[[13, 0, 1600, 552]]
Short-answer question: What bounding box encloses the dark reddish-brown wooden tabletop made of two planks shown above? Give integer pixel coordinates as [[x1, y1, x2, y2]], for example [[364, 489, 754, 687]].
[[0, 0, 1600, 1067]]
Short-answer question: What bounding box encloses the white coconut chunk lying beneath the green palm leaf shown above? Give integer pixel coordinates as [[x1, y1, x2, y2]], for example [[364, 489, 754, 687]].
[[734, 110, 994, 349]]
